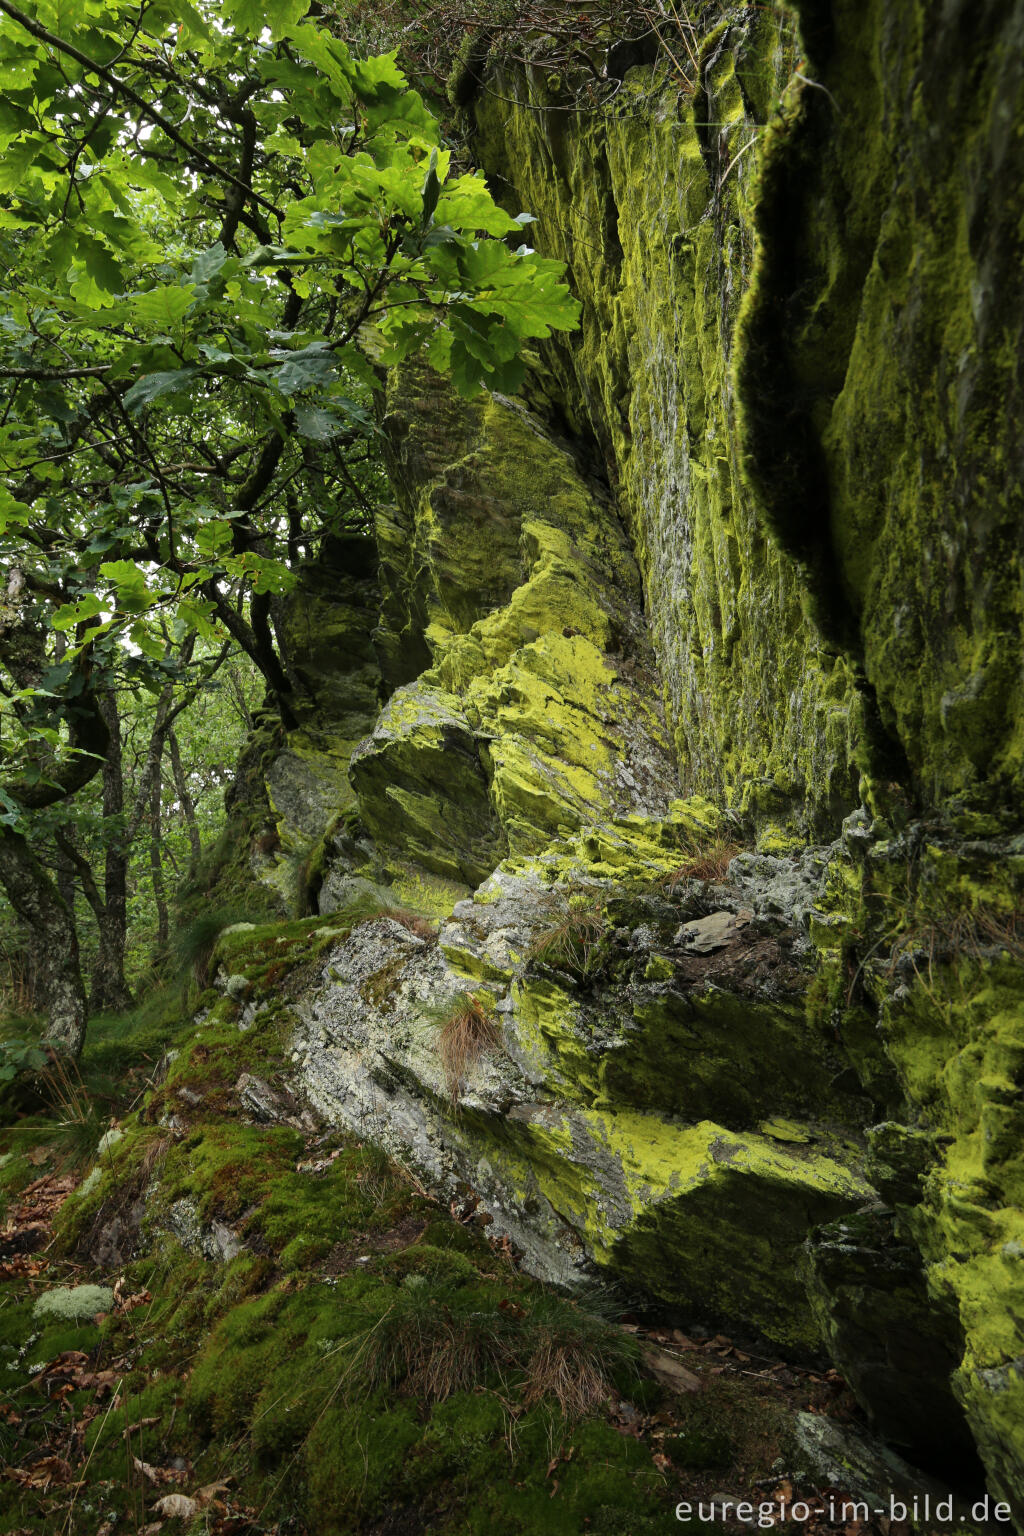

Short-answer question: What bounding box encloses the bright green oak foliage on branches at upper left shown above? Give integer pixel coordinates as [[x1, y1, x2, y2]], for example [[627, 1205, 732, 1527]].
[[0, 0, 577, 792]]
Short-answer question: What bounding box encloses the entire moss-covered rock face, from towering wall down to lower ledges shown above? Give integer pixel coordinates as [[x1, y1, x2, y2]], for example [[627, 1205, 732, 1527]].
[[228, 0, 1024, 1501]]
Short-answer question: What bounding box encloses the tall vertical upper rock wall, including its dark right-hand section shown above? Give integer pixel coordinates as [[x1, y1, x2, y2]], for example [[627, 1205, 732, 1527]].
[[464, 0, 1024, 836]]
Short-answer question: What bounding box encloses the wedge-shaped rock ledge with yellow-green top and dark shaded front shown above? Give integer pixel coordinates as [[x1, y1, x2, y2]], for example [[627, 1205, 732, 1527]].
[[470, 1109, 870, 1355]]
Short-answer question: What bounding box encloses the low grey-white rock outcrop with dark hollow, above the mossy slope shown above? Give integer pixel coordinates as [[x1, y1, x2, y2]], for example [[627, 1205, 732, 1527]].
[[296, 871, 870, 1355]]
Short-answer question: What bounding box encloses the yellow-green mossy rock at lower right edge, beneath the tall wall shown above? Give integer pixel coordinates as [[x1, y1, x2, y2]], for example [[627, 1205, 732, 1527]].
[[815, 831, 1024, 1495]]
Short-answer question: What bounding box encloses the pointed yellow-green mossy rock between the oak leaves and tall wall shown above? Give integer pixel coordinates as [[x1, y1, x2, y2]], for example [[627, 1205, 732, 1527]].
[[352, 351, 677, 885]]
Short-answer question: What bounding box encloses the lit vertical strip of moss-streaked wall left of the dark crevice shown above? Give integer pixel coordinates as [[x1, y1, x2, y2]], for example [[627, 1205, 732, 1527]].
[[471, 29, 863, 837]]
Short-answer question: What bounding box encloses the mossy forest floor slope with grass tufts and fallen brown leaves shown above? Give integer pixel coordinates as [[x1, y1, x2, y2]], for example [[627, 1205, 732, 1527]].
[[0, 991, 970, 1536]]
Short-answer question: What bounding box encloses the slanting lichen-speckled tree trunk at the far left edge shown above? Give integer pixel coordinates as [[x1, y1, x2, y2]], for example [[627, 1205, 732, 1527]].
[[0, 826, 86, 1058]]
